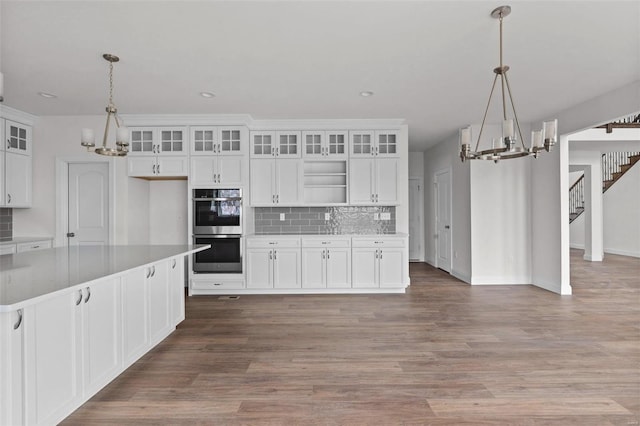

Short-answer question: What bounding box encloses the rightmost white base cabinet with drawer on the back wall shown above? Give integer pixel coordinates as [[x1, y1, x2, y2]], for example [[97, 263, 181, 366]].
[[351, 237, 408, 288]]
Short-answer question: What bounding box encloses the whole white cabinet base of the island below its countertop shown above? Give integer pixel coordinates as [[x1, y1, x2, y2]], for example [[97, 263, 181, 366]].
[[0, 256, 184, 425]]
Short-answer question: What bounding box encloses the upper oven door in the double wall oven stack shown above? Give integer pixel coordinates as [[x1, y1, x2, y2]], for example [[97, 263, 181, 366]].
[[193, 197, 242, 235]]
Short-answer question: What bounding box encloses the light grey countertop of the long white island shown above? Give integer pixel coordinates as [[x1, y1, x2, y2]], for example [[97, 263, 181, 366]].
[[0, 244, 209, 312]]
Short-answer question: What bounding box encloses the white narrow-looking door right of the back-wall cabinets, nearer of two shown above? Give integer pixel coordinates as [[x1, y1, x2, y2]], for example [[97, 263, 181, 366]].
[[435, 170, 451, 273]]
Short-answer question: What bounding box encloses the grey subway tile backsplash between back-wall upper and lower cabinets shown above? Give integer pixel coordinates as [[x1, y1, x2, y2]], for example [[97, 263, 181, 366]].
[[254, 206, 396, 234]]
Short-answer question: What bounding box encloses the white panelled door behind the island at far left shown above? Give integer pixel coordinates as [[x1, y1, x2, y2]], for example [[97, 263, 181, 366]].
[[67, 163, 109, 246]]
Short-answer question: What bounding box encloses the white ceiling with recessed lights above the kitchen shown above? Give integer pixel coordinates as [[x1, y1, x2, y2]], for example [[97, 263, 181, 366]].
[[0, 0, 640, 150]]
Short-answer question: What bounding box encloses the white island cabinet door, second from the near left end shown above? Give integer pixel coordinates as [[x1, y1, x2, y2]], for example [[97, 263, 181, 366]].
[[24, 290, 83, 424]]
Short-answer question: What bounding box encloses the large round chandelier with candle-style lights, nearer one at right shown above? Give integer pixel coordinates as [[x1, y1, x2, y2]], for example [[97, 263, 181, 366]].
[[460, 6, 558, 163]]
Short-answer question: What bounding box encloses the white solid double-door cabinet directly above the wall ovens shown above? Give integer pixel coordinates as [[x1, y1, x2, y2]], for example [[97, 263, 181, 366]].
[[189, 155, 245, 186]]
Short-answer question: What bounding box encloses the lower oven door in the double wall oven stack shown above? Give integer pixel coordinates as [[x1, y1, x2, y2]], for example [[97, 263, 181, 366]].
[[193, 235, 242, 273]]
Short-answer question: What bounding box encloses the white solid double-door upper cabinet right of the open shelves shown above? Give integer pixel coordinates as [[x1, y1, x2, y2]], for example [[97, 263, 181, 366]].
[[349, 158, 400, 205]]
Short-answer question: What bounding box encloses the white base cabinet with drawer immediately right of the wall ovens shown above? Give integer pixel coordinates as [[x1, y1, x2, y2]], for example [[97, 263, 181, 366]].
[[247, 237, 301, 289]]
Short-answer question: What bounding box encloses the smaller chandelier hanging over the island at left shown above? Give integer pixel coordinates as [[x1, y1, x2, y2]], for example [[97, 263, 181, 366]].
[[80, 53, 129, 157]]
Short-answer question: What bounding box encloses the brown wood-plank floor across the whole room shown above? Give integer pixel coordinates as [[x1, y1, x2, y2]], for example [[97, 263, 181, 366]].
[[63, 251, 640, 426]]
